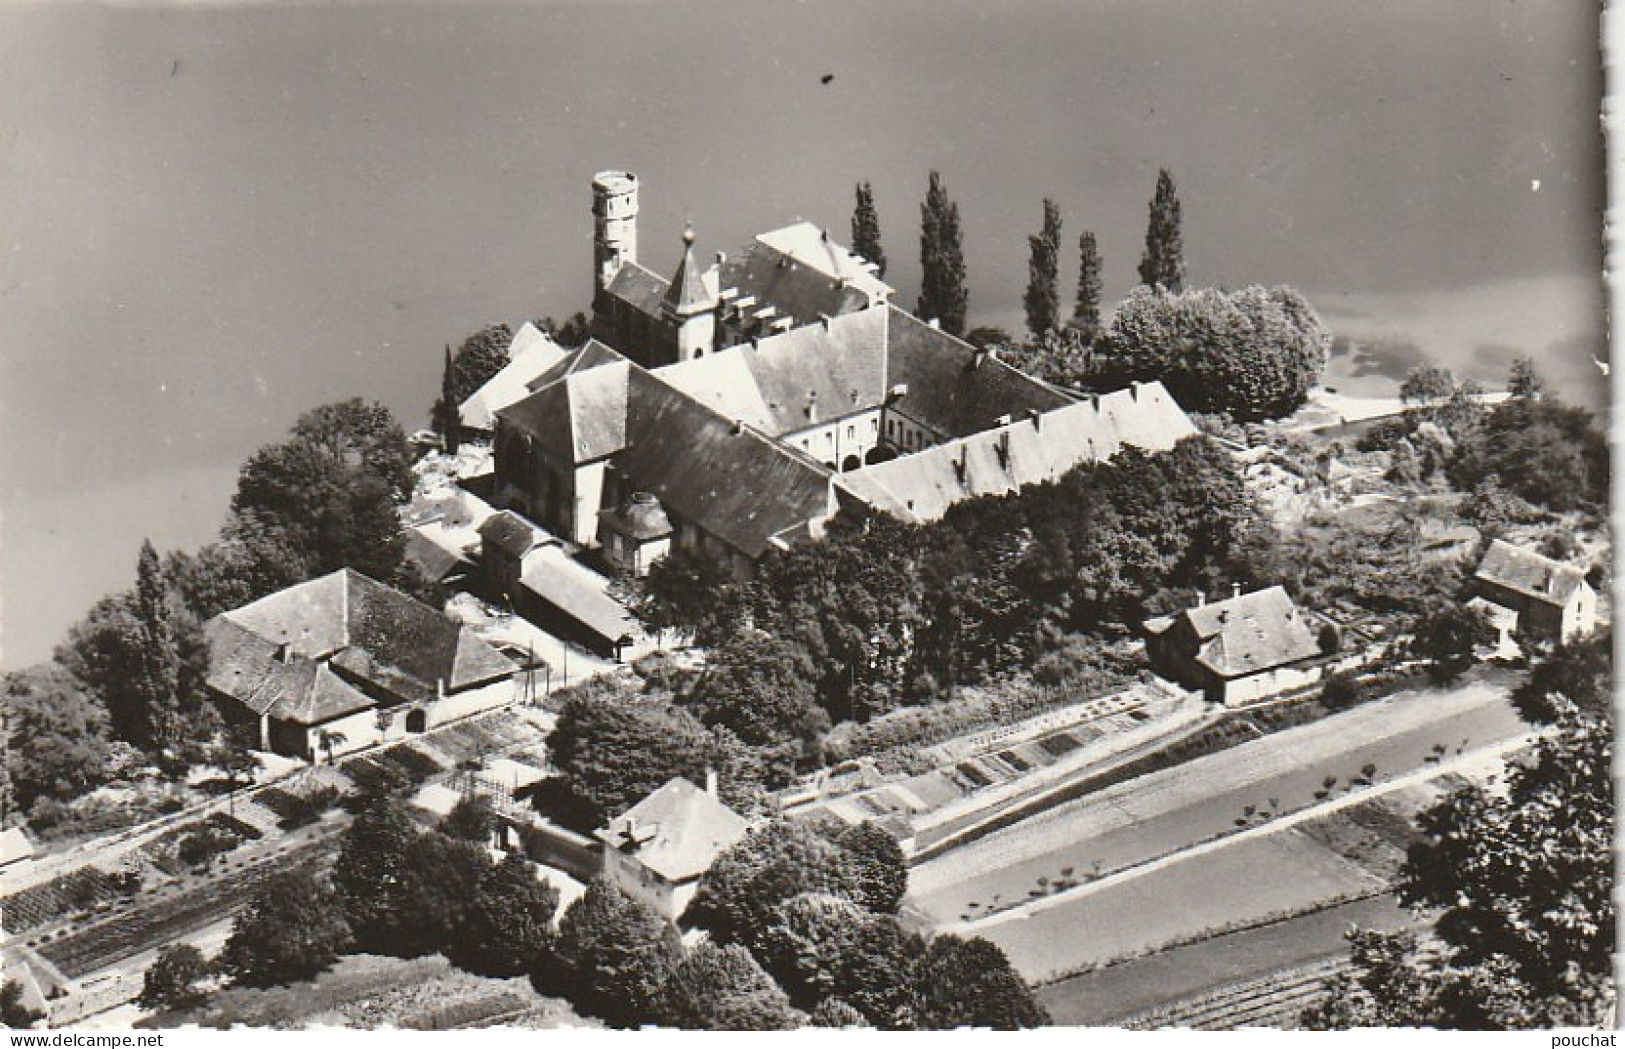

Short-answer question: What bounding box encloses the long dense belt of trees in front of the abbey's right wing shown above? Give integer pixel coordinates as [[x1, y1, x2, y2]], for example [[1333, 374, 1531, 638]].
[[627, 438, 1269, 730]]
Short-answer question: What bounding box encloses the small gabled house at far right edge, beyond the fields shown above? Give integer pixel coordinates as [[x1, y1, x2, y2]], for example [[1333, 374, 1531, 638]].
[[1472, 539, 1597, 641]]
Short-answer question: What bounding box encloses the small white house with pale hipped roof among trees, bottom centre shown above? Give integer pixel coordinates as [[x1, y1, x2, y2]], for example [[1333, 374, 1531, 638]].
[[595, 776, 749, 921]]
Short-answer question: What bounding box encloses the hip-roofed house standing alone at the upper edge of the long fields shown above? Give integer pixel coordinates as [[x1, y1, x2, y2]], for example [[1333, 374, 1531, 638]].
[[1141, 586, 1328, 706]]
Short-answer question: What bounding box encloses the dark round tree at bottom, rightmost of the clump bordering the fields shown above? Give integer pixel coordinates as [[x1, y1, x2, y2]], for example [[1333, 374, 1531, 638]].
[[913, 935, 1051, 1031]]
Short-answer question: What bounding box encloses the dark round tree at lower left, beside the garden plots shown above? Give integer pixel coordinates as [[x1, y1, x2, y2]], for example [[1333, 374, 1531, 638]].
[[221, 869, 349, 987]]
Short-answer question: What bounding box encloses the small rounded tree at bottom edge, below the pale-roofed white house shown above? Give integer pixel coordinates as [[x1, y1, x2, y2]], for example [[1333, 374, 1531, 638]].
[[665, 940, 800, 1031]]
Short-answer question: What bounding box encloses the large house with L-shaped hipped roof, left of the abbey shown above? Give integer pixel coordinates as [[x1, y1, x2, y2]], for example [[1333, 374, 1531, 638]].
[[203, 568, 515, 760]]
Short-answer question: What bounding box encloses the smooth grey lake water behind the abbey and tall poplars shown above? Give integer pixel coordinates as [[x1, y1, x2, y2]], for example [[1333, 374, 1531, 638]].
[[0, 0, 1606, 666]]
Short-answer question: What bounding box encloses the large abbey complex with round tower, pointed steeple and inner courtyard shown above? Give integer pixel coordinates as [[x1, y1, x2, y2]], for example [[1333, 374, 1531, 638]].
[[465, 172, 1194, 576]]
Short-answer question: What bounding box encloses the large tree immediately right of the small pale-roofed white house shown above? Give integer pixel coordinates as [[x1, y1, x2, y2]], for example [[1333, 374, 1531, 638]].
[[683, 820, 856, 961]]
